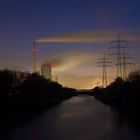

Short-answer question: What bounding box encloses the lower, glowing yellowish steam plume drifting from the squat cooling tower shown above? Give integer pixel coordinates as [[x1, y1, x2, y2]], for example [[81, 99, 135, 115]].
[[43, 52, 99, 71]]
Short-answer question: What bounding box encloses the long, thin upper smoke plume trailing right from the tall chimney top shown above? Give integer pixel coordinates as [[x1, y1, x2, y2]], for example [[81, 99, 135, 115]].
[[35, 30, 140, 43]]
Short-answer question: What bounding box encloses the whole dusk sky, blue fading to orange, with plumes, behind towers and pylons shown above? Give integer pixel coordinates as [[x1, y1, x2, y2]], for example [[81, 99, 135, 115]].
[[0, 0, 140, 89]]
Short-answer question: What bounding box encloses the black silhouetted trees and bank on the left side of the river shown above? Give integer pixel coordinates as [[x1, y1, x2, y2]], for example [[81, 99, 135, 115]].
[[0, 70, 76, 129]]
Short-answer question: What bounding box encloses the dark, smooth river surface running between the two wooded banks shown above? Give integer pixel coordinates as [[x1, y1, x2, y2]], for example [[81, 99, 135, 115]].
[[0, 96, 140, 140]]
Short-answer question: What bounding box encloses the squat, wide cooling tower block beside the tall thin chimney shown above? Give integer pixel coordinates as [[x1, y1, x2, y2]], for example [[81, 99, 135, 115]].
[[41, 63, 52, 80]]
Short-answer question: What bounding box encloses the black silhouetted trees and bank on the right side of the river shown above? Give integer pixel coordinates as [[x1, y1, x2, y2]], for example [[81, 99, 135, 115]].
[[93, 70, 140, 123]]
